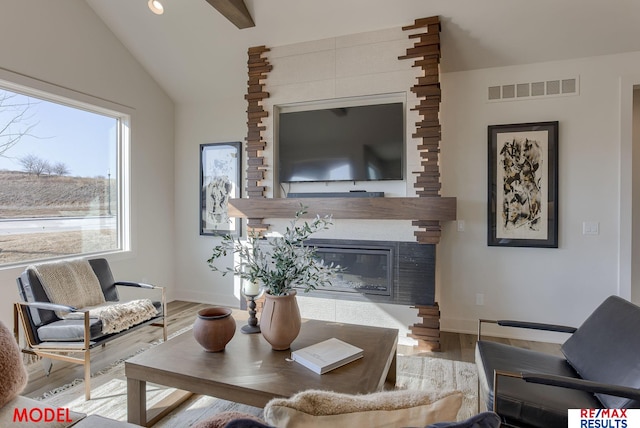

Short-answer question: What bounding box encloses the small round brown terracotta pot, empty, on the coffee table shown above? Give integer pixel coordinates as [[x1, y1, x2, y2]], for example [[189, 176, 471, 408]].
[[193, 307, 236, 352]]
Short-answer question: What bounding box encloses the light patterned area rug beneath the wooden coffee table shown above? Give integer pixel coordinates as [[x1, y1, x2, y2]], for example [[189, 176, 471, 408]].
[[40, 346, 477, 428]]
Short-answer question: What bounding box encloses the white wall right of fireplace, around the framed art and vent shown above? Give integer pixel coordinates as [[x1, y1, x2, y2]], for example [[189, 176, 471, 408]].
[[438, 53, 640, 337]]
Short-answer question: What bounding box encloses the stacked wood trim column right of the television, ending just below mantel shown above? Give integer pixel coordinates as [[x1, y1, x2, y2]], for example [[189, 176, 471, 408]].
[[398, 16, 441, 244]]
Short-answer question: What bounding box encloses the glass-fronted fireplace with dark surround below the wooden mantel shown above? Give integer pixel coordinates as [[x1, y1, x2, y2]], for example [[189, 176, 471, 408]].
[[305, 239, 435, 305]]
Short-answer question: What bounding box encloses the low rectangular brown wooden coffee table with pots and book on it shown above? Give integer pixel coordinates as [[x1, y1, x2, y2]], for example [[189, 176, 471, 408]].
[[125, 320, 398, 425]]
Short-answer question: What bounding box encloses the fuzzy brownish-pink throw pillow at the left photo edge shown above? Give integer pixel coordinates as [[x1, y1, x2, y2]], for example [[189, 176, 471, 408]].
[[0, 321, 28, 408]]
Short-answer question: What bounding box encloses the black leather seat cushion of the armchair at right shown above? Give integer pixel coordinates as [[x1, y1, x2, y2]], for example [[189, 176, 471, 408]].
[[476, 341, 602, 428]]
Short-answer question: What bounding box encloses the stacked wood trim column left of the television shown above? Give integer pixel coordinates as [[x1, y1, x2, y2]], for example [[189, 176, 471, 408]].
[[244, 46, 273, 231]]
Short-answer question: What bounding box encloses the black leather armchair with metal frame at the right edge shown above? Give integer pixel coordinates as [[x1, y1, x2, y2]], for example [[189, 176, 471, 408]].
[[476, 296, 640, 428]]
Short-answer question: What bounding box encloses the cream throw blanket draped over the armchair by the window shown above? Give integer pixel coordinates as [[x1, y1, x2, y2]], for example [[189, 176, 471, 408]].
[[29, 259, 158, 334]]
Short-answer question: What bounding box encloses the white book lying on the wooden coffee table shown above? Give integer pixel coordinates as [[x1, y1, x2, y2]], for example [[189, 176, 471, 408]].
[[291, 337, 363, 374]]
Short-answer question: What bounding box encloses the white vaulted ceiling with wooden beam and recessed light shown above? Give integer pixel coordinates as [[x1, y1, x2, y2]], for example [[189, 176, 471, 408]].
[[86, 0, 640, 103]]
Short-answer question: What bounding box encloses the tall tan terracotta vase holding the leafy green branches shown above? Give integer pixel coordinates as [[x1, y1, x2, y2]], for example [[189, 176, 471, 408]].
[[260, 290, 301, 351]]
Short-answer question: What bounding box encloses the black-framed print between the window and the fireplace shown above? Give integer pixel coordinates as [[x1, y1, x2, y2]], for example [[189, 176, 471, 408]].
[[200, 142, 242, 236]]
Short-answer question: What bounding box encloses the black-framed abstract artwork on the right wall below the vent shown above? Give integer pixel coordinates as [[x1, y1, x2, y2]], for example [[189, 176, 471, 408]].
[[487, 121, 558, 248]]
